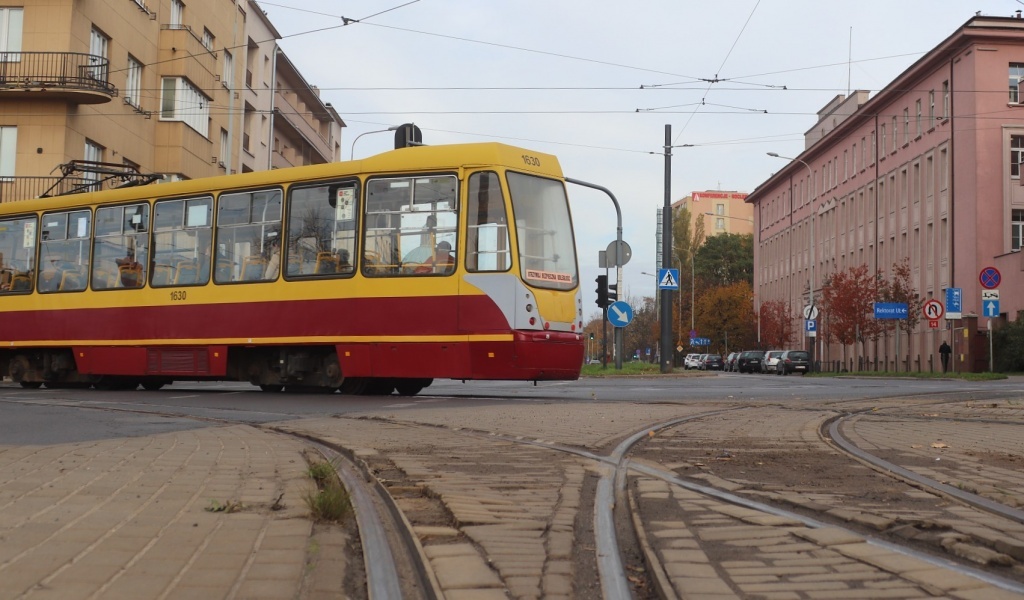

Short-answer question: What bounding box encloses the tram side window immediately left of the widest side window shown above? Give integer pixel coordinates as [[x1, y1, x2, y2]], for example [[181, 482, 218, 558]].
[[285, 182, 359, 278]]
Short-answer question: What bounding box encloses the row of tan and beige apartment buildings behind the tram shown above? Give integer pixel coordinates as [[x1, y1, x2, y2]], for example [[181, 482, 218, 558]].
[[0, 0, 344, 202]]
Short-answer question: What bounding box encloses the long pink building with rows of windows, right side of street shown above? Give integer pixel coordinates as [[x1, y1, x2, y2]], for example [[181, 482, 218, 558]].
[[746, 16, 1024, 371]]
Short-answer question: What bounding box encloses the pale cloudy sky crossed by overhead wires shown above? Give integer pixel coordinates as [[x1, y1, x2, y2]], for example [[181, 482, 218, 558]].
[[253, 0, 1024, 318]]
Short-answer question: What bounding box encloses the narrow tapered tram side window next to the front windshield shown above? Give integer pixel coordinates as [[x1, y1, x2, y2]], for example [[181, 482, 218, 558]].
[[466, 168, 512, 271]]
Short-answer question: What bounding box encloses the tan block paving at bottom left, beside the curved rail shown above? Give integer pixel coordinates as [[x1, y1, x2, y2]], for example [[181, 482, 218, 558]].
[[0, 426, 345, 600]]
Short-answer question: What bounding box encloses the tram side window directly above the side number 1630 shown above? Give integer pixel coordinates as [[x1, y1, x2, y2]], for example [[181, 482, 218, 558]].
[[150, 197, 213, 288]]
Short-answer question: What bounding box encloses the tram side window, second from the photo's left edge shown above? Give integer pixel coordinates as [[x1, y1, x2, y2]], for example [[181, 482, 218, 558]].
[[38, 210, 92, 292]]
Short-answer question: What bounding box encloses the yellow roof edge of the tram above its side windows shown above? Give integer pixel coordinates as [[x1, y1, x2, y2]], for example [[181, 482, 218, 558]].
[[0, 142, 562, 214]]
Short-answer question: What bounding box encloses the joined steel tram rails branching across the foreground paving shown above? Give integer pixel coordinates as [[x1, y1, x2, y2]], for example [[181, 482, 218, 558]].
[[6, 384, 1024, 599]]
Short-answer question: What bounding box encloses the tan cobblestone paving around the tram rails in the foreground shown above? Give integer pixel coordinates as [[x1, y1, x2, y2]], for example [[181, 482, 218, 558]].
[[0, 395, 1024, 600]]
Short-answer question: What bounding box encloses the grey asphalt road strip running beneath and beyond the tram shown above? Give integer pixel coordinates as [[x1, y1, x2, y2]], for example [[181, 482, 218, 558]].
[[0, 374, 1024, 444]]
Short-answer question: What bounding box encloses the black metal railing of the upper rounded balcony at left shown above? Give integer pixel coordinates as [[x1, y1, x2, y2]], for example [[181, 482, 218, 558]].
[[0, 52, 118, 97]]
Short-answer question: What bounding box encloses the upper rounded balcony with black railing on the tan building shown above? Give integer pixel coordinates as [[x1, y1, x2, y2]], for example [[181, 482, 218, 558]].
[[0, 52, 118, 104]]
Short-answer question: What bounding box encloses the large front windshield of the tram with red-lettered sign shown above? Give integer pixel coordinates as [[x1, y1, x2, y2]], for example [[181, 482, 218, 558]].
[[508, 173, 580, 290]]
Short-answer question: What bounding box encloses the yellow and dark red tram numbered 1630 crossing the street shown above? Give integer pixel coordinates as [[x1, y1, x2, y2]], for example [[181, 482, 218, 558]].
[[0, 143, 584, 395]]
